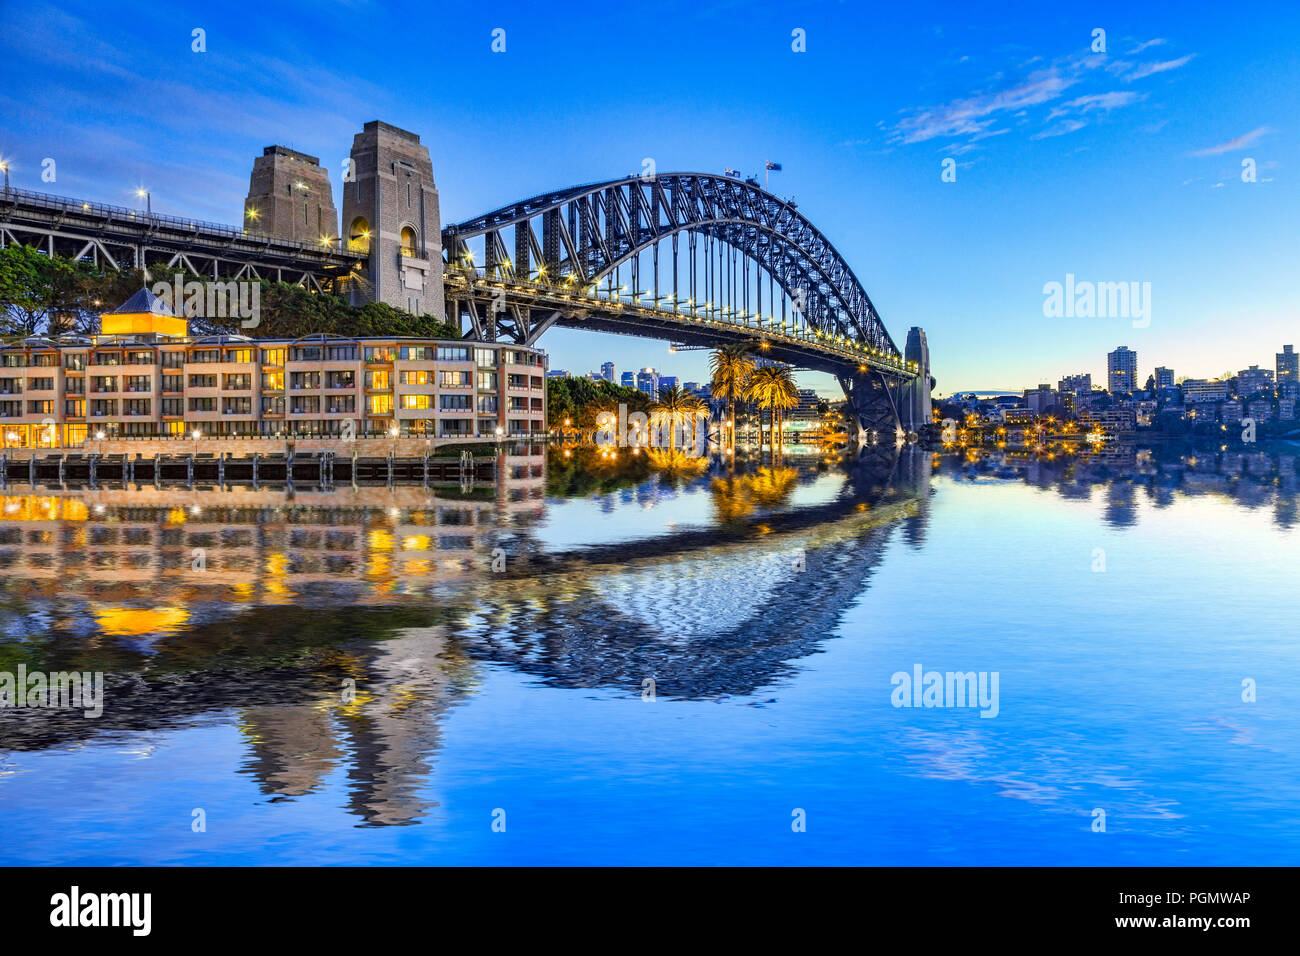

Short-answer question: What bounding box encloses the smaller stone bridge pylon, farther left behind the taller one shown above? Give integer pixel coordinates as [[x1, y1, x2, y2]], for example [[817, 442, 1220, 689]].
[[244, 146, 338, 247]]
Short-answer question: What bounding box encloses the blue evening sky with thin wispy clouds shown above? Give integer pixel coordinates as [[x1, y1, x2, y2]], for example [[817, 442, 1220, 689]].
[[0, 0, 1300, 395]]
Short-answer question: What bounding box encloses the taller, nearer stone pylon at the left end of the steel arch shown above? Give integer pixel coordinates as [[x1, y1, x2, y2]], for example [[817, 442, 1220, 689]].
[[343, 120, 446, 321]]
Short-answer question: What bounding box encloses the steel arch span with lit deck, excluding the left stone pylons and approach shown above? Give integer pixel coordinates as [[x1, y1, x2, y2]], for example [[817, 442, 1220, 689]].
[[442, 173, 932, 436]]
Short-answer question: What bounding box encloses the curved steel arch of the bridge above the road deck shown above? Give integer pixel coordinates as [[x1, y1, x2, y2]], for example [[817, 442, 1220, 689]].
[[443, 173, 900, 356]]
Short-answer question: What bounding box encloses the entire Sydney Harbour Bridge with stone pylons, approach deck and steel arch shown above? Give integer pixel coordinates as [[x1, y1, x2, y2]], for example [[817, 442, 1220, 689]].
[[0, 121, 935, 441]]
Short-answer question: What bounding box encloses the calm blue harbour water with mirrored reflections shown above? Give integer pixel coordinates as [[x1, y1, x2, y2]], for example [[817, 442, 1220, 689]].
[[0, 446, 1300, 865]]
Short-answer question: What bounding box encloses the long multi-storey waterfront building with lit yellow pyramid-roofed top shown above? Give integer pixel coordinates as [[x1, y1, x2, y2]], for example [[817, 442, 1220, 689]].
[[0, 290, 546, 447]]
